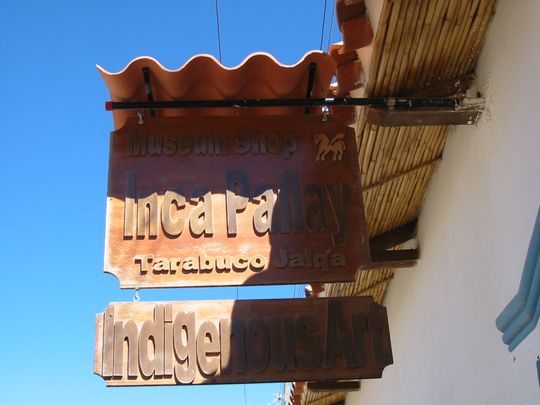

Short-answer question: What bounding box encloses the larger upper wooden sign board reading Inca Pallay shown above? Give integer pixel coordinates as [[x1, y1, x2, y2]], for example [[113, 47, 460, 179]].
[[105, 116, 369, 288]]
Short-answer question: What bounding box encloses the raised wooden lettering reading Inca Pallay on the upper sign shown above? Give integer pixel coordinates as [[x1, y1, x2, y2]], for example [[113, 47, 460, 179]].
[[124, 170, 350, 241]]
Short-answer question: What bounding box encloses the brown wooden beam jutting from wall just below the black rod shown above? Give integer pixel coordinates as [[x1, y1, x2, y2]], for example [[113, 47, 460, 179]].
[[367, 107, 481, 127]]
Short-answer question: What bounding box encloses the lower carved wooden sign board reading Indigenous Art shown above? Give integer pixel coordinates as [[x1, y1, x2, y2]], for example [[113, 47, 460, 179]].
[[94, 297, 393, 386]]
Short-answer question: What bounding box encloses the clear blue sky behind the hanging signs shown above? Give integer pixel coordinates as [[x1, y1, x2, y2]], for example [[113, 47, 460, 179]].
[[0, 0, 339, 405]]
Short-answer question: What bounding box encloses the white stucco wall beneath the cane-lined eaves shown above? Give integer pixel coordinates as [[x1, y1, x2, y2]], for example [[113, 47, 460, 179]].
[[346, 0, 540, 405]]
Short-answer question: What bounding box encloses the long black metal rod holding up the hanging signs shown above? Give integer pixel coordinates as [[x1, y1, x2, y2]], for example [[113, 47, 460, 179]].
[[105, 97, 477, 111]]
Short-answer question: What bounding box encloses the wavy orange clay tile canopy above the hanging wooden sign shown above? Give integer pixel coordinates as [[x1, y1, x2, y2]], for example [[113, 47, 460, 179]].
[[97, 51, 336, 128]]
